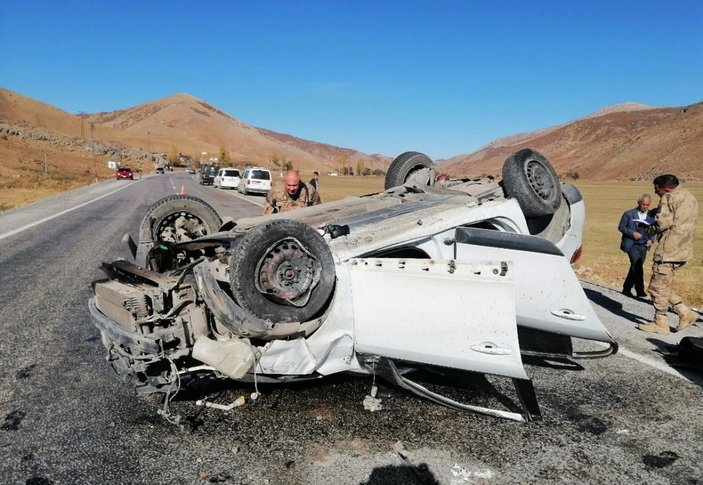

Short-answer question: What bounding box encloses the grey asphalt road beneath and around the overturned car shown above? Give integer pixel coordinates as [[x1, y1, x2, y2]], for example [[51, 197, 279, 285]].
[[0, 174, 703, 484]]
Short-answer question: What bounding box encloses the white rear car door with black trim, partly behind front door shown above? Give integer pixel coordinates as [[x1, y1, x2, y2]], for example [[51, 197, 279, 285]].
[[455, 227, 614, 343]]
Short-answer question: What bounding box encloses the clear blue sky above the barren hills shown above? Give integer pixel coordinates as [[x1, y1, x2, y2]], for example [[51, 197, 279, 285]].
[[0, 0, 703, 158]]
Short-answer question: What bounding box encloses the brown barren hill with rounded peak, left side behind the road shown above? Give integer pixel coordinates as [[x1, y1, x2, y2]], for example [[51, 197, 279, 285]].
[[0, 88, 390, 171]]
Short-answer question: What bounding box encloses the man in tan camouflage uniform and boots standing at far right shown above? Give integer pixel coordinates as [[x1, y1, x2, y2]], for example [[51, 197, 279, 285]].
[[637, 174, 699, 335]]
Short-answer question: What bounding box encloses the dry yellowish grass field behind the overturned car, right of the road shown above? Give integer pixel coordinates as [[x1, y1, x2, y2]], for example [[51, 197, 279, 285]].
[[310, 174, 703, 307]]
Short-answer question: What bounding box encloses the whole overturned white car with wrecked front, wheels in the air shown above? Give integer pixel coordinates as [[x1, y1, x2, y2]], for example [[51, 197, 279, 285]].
[[89, 149, 617, 420]]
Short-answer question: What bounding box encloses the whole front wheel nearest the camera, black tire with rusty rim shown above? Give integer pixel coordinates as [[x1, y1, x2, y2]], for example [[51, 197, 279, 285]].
[[229, 219, 335, 322]]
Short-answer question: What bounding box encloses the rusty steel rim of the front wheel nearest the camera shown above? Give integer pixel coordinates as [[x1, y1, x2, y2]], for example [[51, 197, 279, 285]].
[[255, 238, 322, 306]]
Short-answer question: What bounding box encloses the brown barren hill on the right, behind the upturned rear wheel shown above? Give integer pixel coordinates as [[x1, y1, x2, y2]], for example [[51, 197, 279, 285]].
[[441, 103, 703, 180]]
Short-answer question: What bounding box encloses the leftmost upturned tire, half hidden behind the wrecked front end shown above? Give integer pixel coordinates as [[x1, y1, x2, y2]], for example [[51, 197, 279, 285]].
[[139, 195, 222, 242]]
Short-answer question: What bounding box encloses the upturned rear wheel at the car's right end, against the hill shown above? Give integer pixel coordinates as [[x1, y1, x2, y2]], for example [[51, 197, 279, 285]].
[[503, 148, 562, 218]]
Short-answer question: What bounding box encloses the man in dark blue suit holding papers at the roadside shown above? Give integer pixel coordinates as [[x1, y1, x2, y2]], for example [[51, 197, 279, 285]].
[[618, 194, 654, 298]]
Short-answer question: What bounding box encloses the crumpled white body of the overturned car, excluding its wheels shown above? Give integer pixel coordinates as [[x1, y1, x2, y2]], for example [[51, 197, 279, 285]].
[[90, 173, 617, 420]]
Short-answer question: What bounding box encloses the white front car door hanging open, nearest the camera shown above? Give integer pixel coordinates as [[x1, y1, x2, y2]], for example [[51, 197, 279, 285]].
[[350, 258, 526, 379]]
